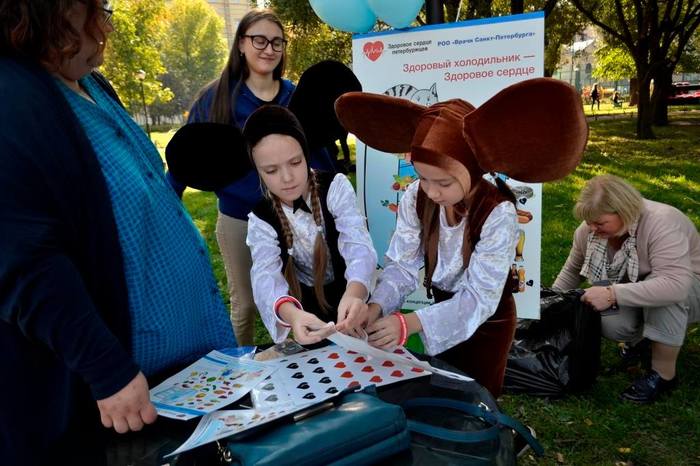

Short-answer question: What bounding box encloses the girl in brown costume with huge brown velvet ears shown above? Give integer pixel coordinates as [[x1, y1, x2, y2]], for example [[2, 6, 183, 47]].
[[336, 78, 588, 396]]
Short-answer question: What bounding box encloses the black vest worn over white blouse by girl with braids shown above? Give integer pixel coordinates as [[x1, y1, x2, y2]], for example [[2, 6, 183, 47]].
[[253, 171, 347, 322]]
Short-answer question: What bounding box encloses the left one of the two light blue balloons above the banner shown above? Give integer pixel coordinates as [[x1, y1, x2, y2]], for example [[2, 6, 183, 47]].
[[309, 0, 377, 32]]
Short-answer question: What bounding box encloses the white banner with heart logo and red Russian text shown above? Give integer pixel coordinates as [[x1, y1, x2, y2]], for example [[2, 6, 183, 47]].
[[352, 12, 546, 318]]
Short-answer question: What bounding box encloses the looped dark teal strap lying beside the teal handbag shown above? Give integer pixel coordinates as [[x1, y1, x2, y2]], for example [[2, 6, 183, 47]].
[[401, 398, 544, 456]]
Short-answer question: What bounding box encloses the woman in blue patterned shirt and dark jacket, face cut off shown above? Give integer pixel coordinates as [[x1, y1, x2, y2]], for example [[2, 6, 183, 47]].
[[0, 0, 235, 466]]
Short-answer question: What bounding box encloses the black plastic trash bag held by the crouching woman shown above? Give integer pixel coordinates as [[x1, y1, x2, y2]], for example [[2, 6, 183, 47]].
[[504, 288, 601, 398]]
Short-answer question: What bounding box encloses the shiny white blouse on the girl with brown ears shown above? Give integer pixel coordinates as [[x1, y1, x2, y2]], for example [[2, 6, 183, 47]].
[[369, 181, 517, 355]]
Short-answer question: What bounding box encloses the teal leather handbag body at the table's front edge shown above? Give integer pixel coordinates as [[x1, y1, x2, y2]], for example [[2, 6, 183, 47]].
[[222, 393, 411, 466]]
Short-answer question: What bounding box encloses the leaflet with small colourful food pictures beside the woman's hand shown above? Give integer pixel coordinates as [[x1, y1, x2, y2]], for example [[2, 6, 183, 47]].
[[150, 351, 275, 420]]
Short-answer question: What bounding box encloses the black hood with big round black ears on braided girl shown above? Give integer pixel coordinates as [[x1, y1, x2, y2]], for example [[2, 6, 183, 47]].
[[165, 60, 362, 191]]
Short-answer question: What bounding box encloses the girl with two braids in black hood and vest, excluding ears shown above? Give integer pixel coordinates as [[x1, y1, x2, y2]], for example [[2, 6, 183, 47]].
[[243, 105, 377, 344]]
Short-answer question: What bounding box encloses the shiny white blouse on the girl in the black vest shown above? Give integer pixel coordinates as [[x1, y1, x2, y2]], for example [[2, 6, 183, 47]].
[[246, 174, 377, 343]]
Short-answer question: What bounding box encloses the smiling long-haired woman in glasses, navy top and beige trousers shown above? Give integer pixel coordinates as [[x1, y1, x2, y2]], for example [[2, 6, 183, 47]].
[[169, 10, 335, 345]]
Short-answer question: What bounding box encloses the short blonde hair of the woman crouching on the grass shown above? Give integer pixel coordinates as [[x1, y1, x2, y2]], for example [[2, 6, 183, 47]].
[[574, 175, 644, 229]]
